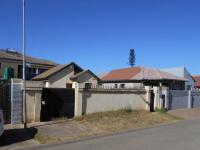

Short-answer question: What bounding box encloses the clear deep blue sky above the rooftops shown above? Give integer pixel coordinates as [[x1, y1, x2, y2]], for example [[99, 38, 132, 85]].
[[0, 0, 200, 74]]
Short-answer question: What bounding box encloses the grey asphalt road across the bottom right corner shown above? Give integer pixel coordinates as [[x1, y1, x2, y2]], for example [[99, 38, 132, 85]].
[[31, 119, 200, 150]]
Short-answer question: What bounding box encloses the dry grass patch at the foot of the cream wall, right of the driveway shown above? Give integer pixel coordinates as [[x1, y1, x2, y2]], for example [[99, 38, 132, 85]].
[[75, 109, 180, 132]]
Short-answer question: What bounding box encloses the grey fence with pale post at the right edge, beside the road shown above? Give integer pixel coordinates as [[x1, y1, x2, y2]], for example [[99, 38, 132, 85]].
[[169, 90, 200, 110]]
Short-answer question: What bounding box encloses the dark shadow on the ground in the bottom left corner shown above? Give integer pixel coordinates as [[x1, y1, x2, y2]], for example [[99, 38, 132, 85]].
[[0, 128, 37, 146]]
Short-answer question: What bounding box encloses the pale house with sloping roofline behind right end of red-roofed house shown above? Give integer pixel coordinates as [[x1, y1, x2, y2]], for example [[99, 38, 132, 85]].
[[162, 67, 195, 90]]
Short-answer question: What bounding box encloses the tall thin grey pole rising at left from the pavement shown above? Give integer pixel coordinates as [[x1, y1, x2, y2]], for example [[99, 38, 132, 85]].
[[22, 0, 27, 128]]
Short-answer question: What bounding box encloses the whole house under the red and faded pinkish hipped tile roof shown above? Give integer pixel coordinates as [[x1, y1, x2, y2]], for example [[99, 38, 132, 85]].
[[99, 67, 186, 90]]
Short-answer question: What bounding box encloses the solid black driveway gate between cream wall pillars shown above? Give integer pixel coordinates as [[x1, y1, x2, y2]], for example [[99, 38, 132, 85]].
[[40, 88, 75, 121]]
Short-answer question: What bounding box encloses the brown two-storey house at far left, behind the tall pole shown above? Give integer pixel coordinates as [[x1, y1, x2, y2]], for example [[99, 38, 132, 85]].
[[0, 49, 57, 80]]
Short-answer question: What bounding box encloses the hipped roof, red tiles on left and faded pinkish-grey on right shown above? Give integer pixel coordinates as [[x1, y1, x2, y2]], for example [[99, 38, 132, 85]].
[[101, 67, 187, 81]]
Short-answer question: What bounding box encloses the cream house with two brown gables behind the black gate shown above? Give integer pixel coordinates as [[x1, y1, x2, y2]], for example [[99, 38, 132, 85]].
[[33, 62, 99, 88]]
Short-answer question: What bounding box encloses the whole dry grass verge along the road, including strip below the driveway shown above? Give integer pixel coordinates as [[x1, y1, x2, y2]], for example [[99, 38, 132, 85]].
[[34, 108, 179, 144]]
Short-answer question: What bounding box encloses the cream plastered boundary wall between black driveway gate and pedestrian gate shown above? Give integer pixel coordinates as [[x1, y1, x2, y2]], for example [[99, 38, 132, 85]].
[[75, 89, 148, 115]]
